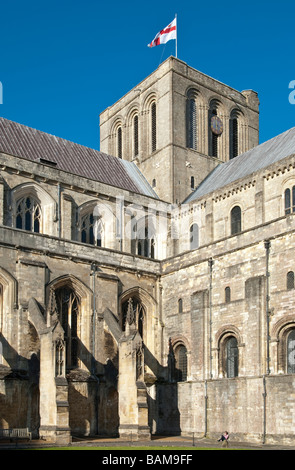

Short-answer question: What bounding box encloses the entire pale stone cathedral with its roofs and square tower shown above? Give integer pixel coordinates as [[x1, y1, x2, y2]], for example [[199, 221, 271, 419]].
[[0, 57, 295, 445]]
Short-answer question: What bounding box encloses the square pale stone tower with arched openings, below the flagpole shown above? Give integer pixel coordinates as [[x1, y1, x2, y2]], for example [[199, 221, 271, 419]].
[[100, 57, 259, 204]]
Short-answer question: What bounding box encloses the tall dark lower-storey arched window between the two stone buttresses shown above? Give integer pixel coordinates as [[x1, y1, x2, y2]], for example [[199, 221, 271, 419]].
[[55, 286, 80, 368]]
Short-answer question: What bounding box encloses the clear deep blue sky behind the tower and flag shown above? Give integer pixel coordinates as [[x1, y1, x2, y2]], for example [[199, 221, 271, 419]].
[[0, 0, 295, 149]]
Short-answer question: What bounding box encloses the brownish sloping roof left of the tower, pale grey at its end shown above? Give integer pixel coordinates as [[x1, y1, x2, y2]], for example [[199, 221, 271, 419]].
[[0, 117, 157, 198]]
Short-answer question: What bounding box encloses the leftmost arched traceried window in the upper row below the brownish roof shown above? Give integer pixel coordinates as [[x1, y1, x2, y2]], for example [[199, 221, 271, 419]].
[[16, 196, 41, 233]]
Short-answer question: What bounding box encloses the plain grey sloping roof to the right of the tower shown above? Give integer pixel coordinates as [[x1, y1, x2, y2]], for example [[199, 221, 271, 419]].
[[184, 127, 295, 203]]
